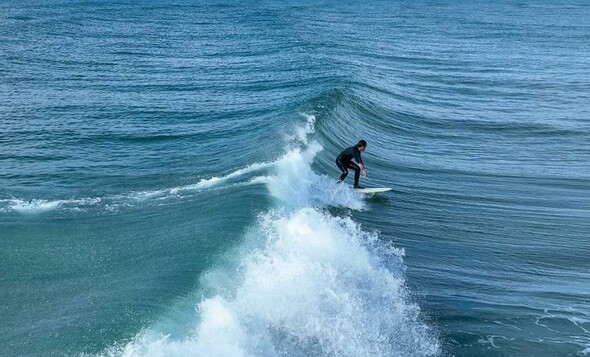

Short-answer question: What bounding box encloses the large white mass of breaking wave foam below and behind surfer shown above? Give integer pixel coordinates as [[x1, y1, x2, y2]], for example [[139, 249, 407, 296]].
[[107, 114, 440, 357]]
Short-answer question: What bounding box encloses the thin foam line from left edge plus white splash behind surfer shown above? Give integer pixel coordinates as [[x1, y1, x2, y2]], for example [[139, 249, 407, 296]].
[[0, 114, 332, 214]]
